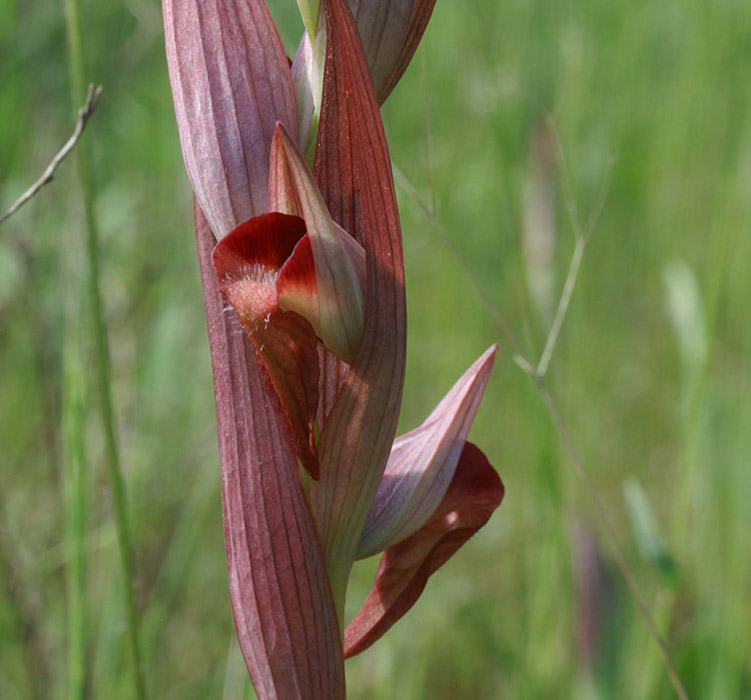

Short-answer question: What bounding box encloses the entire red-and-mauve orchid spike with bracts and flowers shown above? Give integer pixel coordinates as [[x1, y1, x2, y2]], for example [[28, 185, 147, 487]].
[[163, 0, 503, 700]]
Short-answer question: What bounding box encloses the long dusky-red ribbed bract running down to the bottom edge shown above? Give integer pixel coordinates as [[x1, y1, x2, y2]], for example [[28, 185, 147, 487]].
[[196, 207, 344, 700]]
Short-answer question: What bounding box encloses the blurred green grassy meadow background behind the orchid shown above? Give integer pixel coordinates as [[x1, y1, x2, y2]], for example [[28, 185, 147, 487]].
[[0, 0, 751, 700]]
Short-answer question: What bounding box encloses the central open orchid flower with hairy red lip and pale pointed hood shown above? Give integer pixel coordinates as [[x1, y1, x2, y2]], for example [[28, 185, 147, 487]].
[[213, 123, 365, 479]]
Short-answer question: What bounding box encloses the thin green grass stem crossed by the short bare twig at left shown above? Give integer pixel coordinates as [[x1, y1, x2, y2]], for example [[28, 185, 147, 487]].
[[65, 0, 146, 700]]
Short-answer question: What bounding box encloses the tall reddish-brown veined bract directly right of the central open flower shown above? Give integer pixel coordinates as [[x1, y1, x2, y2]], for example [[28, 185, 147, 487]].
[[310, 0, 406, 562]]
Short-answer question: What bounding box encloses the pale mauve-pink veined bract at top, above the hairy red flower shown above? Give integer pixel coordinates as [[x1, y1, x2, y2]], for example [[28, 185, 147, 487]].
[[162, 0, 297, 238]]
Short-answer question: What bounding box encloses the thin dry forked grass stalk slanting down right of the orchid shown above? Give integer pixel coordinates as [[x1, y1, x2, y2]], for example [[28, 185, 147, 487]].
[[394, 163, 688, 700]]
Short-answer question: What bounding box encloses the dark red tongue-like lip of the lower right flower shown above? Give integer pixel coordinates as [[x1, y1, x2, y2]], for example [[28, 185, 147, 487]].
[[344, 442, 504, 658]]
